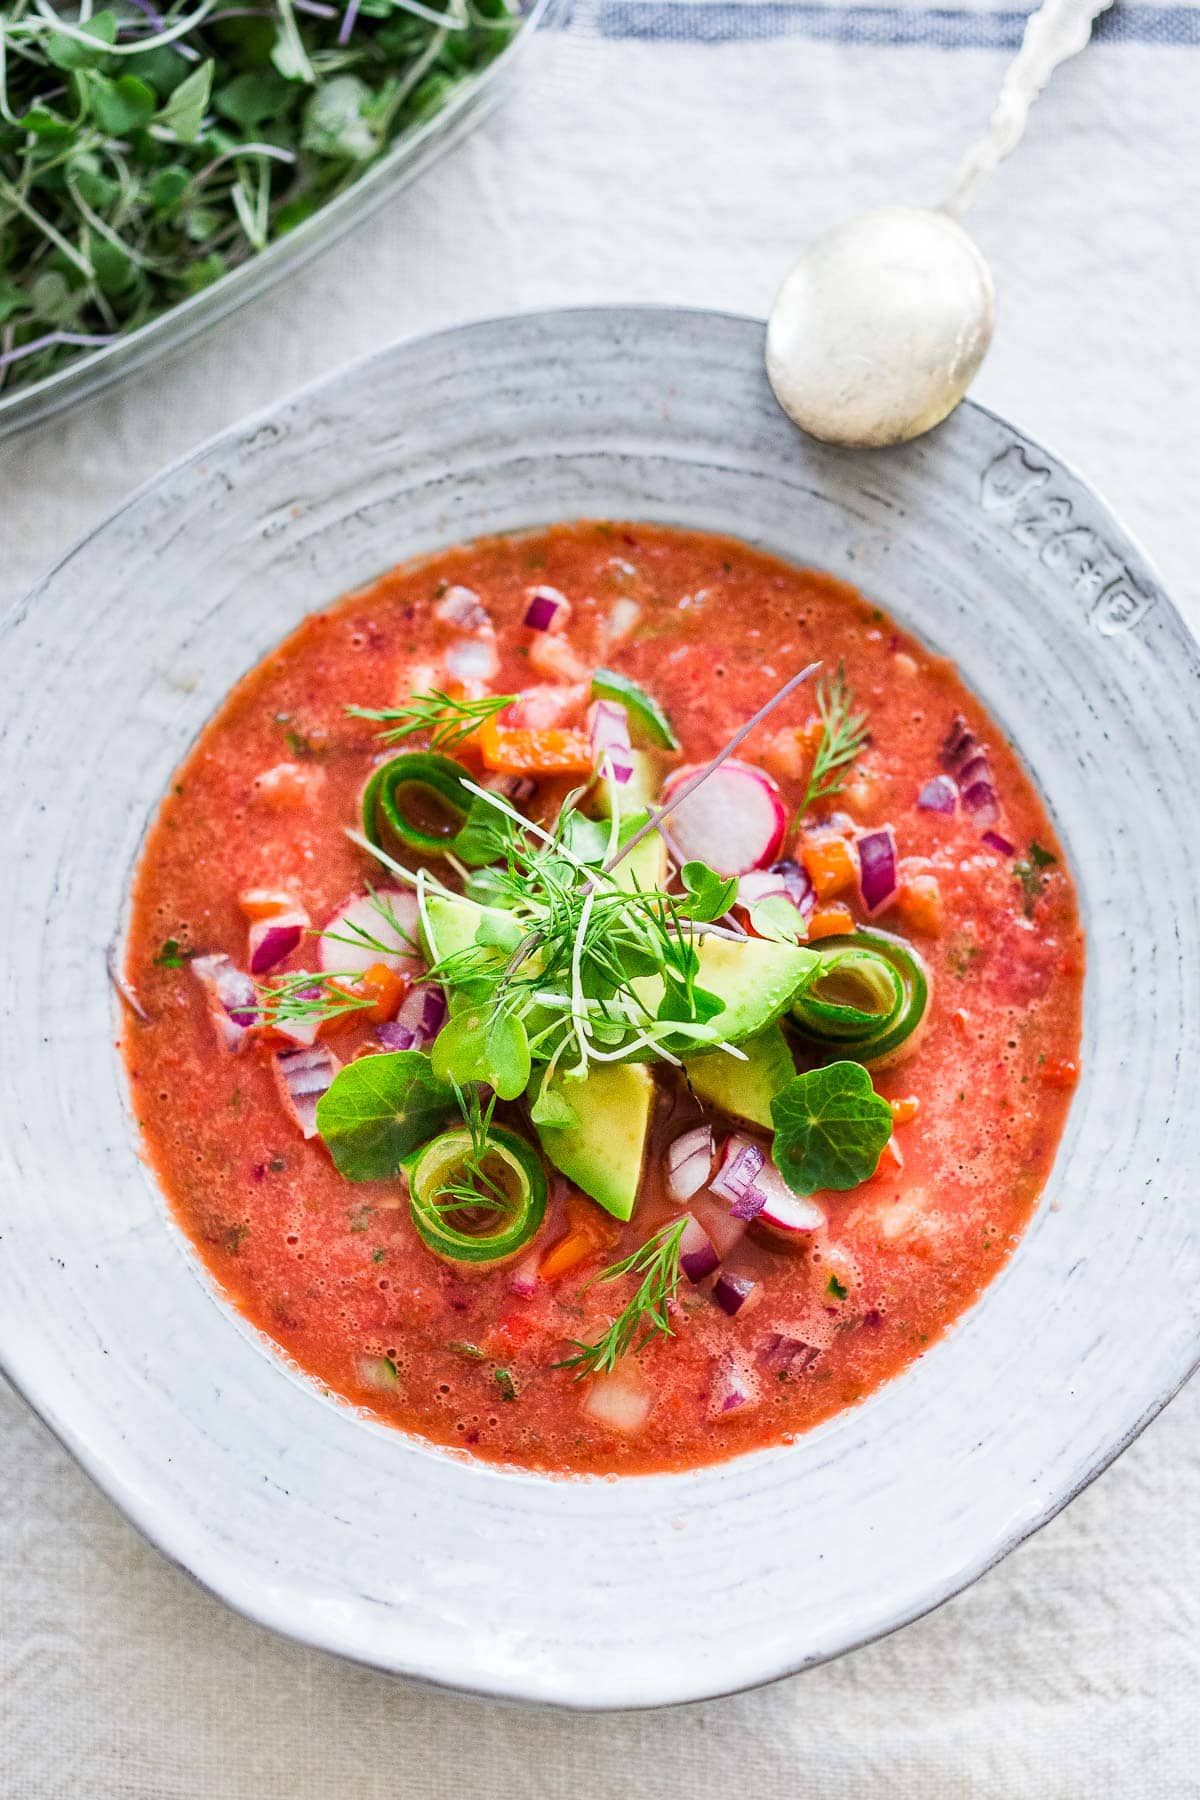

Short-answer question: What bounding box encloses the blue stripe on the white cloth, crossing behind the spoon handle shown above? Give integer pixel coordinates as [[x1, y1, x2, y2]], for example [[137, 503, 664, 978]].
[[563, 0, 1200, 50]]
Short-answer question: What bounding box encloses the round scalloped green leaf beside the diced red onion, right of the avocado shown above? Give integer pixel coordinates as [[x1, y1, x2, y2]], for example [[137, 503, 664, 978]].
[[770, 1062, 892, 1193]]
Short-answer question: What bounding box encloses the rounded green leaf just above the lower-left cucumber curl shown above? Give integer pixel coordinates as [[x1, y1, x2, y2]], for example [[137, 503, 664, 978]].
[[317, 1049, 457, 1181]]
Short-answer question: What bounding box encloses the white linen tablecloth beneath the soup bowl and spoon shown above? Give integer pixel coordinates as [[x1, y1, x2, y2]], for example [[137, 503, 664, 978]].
[[0, 0, 1200, 1800]]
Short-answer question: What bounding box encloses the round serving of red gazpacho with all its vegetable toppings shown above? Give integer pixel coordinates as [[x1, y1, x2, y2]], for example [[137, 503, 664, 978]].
[[122, 524, 1083, 1472]]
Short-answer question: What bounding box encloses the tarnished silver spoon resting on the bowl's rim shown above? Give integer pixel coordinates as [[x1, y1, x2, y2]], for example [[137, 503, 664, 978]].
[[766, 0, 1112, 448]]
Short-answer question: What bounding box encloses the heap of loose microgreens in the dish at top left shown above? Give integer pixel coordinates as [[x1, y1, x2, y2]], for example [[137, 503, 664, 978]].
[[0, 0, 518, 389]]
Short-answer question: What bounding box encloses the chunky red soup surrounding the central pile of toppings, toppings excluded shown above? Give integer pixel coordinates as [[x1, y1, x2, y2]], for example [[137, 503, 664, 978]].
[[124, 524, 1083, 1472]]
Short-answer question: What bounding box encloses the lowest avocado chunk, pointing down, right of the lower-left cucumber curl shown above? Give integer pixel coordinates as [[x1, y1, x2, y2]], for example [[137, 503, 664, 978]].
[[538, 1062, 655, 1219]]
